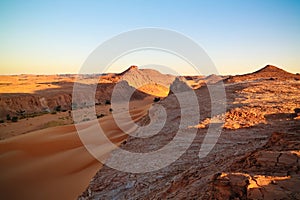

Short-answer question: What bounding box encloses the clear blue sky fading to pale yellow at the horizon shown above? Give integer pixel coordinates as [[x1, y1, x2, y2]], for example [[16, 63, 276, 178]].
[[0, 0, 300, 74]]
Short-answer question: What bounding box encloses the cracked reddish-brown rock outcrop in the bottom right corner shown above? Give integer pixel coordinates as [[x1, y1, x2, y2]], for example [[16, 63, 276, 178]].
[[209, 133, 300, 199]]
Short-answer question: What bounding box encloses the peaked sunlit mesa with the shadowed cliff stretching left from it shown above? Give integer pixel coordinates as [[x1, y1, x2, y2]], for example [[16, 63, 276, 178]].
[[0, 66, 175, 119]]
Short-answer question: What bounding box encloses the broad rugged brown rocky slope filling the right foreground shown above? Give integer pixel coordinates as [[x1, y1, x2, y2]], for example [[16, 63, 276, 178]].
[[79, 65, 300, 199]]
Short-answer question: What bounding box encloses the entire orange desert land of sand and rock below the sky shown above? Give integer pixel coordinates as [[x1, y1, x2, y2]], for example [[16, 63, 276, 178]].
[[0, 65, 300, 199]]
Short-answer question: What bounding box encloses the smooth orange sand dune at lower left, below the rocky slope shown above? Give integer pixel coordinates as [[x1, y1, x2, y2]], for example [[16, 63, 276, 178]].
[[0, 104, 149, 199]]
